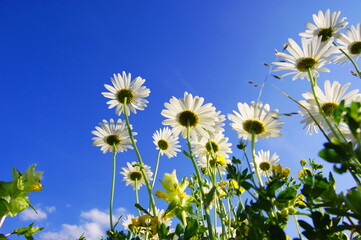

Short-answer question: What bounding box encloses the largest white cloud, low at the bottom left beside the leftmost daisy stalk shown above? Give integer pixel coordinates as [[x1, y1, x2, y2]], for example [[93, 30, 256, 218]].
[[40, 208, 127, 240]]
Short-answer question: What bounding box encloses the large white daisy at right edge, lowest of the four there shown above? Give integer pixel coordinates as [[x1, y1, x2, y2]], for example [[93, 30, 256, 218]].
[[300, 80, 360, 135]]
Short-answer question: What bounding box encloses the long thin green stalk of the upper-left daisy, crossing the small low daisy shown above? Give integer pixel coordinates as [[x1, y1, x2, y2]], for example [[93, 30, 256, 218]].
[[123, 97, 157, 216]]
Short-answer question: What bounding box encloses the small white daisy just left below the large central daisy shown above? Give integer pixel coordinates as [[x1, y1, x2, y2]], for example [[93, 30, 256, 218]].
[[153, 127, 180, 158]]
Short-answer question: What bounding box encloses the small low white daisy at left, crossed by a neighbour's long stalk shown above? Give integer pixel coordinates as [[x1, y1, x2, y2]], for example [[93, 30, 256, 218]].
[[120, 162, 153, 190]]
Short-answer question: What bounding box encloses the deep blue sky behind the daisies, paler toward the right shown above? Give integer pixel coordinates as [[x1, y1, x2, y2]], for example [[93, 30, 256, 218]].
[[0, 0, 361, 239]]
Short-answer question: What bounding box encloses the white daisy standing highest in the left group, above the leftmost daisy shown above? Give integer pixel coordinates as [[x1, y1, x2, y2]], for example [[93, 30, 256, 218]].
[[102, 71, 150, 115]]
